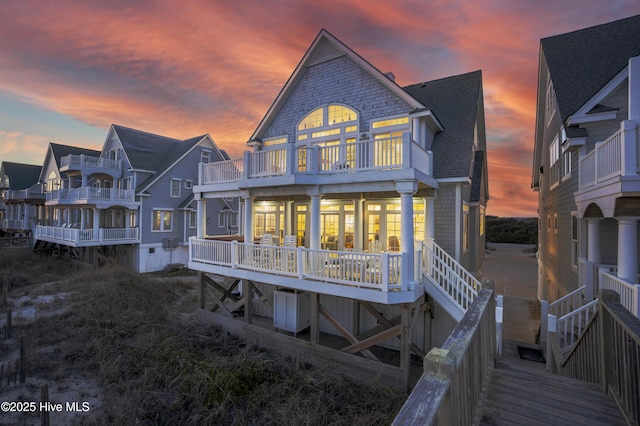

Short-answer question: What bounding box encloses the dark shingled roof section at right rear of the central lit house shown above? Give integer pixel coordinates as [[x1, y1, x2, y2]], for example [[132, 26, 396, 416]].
[[404, 71, 482, 178]]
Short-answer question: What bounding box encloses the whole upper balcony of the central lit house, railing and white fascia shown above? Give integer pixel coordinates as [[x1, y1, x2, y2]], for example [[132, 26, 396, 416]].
[[199, 133, 433, 189]]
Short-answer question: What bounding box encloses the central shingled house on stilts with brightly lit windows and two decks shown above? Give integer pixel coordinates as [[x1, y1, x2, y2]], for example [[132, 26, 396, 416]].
[[189, 30, 489, 390]]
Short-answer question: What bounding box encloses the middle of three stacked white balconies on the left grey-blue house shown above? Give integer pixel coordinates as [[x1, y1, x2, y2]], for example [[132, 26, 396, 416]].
[[46, 187, 137, 208]]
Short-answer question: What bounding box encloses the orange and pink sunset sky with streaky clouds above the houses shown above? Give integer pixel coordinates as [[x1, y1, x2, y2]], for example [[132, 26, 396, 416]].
[[0, 0, 640, 217]]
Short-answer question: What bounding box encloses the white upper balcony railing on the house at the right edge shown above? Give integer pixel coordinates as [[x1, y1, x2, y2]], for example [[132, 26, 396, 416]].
[[579, 121, 640, 190]]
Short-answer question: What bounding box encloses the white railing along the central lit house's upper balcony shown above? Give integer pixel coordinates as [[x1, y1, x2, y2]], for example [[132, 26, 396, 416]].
[[199, 133, 433, 185]]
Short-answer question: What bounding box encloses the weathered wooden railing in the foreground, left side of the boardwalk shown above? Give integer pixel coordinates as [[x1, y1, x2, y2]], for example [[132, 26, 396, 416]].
[[393, 287, 497, 426]]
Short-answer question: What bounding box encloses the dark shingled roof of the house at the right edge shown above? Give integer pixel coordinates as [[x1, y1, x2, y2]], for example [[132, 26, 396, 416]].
[[540, 15, 640, 122]]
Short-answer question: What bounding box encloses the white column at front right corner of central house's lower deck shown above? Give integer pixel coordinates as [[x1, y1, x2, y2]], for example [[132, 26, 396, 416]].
[[396, 181, 418, 290]]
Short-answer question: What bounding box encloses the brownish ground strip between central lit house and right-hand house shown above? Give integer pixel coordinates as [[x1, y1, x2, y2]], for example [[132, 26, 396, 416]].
[[483, 243, 540, 344]]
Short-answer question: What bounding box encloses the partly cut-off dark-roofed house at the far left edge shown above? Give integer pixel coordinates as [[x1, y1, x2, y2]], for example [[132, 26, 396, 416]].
[[0, 161, 44, 236]]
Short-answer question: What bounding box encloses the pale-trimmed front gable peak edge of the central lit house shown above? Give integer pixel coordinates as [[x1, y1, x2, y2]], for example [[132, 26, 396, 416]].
[[249, 28, 424, 142]]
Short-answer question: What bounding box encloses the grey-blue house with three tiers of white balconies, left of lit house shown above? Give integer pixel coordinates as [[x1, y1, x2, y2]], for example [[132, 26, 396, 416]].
[[35, 125, 237, 272]]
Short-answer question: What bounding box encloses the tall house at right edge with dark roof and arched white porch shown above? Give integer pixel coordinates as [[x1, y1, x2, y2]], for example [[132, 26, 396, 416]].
[[532, 16, 640, 301]]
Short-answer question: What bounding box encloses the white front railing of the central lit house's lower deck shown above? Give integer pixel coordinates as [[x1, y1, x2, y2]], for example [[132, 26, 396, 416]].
[[189, 238, 406, 291]]
